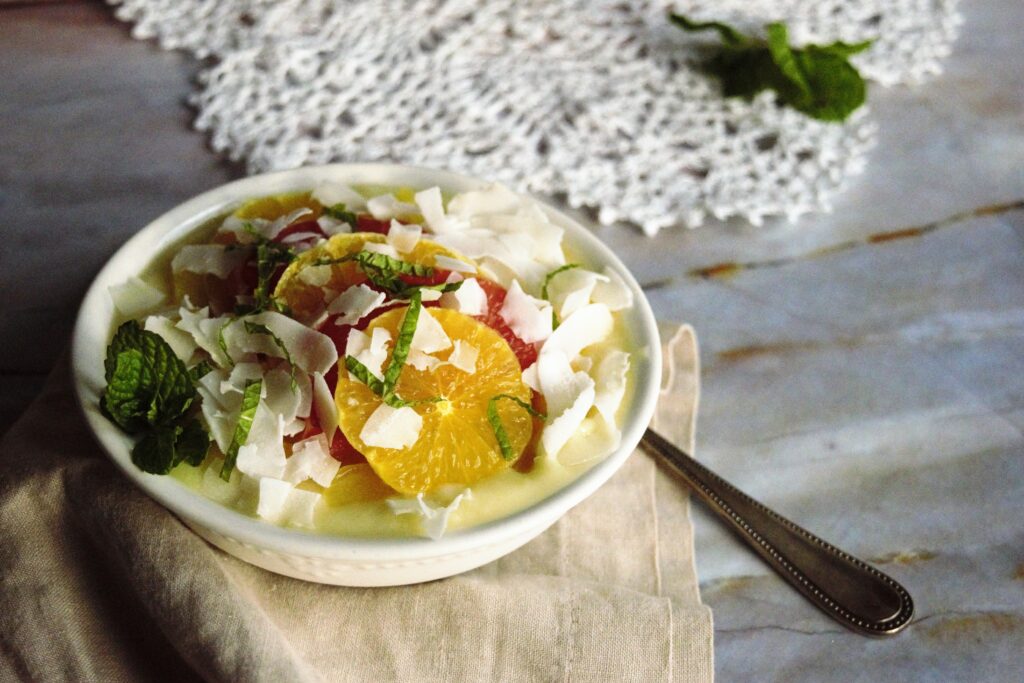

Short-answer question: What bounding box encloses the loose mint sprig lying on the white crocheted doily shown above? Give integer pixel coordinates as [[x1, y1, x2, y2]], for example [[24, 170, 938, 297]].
[[669, 14, 872, 121]]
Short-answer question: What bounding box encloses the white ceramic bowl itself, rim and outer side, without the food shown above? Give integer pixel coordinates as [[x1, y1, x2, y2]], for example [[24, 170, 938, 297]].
[[72, 164, 662, 586]]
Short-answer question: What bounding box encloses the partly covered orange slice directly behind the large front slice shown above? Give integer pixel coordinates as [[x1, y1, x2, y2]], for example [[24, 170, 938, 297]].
[[273, 232, 471, 319]]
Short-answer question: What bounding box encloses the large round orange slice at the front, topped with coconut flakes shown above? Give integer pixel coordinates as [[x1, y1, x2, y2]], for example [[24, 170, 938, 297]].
[[335, 306, 534, 494]]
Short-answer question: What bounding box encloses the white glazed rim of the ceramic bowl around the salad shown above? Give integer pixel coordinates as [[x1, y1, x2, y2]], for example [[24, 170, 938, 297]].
[[72, 164, 662, 560]]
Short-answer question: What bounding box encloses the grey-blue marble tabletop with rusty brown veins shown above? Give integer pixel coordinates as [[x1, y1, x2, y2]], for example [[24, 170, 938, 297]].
[[0, 0, 1024, 681]]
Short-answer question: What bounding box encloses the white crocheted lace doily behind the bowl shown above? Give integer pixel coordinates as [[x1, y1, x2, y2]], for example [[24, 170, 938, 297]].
[[112, 0, 959, 233]]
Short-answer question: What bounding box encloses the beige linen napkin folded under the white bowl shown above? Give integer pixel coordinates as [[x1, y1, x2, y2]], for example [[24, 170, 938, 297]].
[[0, 327, 713, 681]]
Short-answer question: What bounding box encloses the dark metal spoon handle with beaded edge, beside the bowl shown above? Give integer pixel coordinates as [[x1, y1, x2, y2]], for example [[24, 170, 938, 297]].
[[640, 429, 913, 636]]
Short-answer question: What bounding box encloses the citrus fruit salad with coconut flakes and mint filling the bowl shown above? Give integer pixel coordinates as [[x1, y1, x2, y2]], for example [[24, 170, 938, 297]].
[[100, 182, 633, 539]]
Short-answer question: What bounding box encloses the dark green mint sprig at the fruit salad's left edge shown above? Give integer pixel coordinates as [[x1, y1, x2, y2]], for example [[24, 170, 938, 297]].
[[100, 321, 210, 474]]
